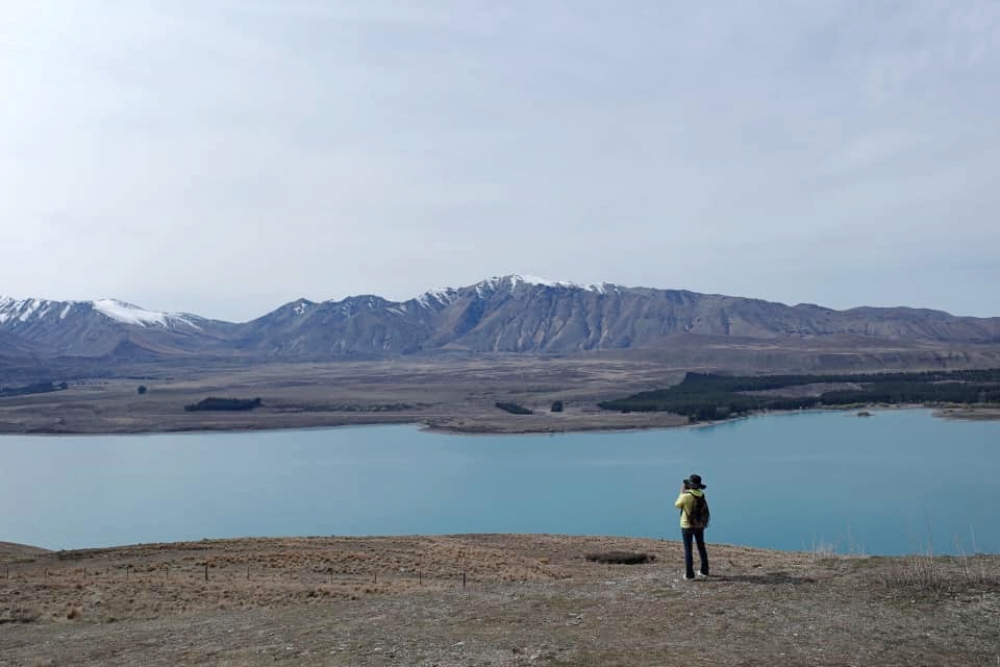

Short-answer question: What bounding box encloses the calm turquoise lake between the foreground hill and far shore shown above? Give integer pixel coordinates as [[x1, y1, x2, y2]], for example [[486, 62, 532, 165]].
[[0, 410, 1000, 554]]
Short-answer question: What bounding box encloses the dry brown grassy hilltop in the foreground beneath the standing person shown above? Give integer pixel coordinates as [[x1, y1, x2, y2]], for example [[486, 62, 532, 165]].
[[0, 531, 1000, 667]]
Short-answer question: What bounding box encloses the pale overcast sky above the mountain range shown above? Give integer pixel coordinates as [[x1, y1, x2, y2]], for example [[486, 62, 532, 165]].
[[0, 0, 1000, 320]]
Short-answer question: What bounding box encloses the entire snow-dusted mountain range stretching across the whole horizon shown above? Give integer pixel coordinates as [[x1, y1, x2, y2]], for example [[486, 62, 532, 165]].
[[0, 275, 1000, 376]]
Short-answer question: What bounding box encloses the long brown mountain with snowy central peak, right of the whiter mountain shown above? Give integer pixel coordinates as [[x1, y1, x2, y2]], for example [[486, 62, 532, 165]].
[[233, 275, 996, 358]]
